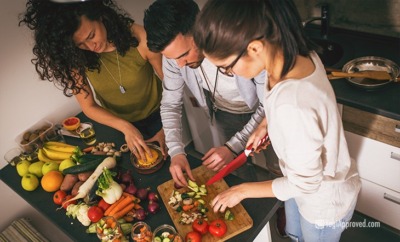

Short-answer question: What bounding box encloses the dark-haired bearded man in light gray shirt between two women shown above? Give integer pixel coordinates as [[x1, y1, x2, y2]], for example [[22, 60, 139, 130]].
[[144, 0, 265, 186]]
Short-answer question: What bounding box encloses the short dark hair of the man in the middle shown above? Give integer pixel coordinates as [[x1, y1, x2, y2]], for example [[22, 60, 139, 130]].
[[143, 0, 200, 53]]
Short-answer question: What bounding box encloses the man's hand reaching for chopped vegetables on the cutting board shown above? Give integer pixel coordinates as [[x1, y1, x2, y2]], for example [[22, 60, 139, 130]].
[[169, 154, 195, 187]]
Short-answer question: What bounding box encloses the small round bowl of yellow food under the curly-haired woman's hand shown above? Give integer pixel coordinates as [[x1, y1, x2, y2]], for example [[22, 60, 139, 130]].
[[130, 143, 164, 174]]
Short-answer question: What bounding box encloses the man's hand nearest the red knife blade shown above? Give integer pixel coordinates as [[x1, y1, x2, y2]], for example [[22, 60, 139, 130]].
[[201, 146, 233, 171]]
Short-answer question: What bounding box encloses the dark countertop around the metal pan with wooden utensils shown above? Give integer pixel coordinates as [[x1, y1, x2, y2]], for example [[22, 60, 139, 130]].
[[306, 25, 400, 120]]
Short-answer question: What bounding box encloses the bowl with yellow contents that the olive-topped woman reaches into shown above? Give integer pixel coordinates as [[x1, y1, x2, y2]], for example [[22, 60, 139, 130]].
[[130, 143, 164, 174]]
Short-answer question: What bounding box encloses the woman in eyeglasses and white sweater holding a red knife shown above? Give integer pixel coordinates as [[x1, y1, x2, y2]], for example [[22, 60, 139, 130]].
[[194, 0, 361, 241]]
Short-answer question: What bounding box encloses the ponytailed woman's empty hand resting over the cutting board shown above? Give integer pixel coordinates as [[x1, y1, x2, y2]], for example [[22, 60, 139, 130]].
[[211, 185, 246, 213]]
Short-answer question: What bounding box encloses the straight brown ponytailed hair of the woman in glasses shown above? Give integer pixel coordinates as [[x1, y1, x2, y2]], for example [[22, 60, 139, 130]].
[[193, 0, 316, 77]]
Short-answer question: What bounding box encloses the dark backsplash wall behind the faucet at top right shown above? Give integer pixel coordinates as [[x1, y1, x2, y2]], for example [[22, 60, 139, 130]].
[[294, 0, 400, 38]]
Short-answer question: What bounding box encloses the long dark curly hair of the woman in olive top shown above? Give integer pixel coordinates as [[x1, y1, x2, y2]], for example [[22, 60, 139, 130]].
[[19, 0, 139, 97]]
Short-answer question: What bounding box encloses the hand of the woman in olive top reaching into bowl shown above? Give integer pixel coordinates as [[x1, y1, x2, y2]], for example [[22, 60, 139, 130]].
[[124, 125, 151, 160]]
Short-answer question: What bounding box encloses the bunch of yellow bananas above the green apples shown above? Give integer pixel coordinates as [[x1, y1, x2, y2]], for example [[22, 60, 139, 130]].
[[38, 141, 82, 163]]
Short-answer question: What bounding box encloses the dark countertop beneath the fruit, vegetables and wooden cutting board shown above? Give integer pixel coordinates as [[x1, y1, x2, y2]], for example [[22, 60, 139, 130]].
[[0, 113, 280, 242]]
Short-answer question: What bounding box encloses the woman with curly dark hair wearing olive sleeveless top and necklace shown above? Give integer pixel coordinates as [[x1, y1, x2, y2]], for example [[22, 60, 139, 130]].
[[20, 0, 166, 159]]
